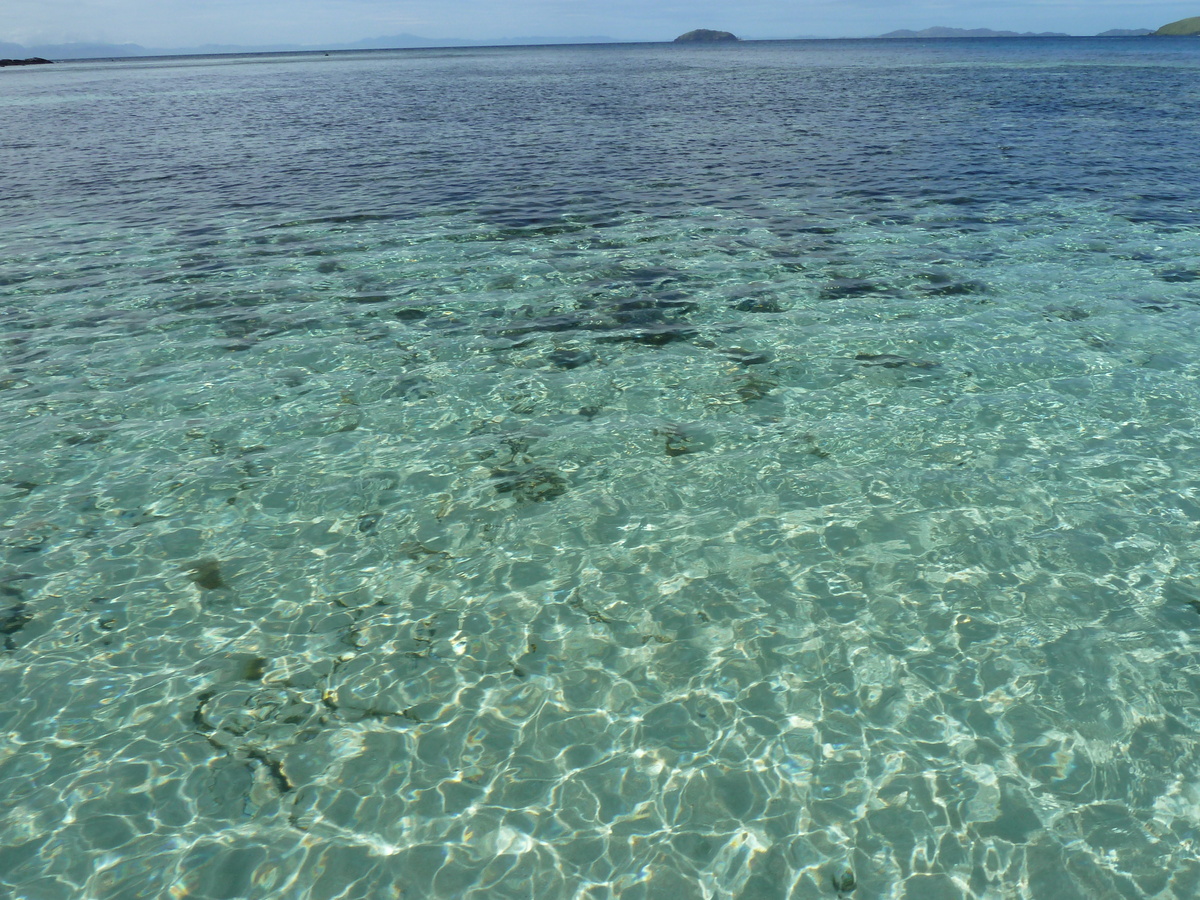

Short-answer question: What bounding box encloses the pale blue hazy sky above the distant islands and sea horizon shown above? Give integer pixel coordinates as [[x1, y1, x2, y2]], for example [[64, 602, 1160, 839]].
[[0, 0, 1200, 48]]
